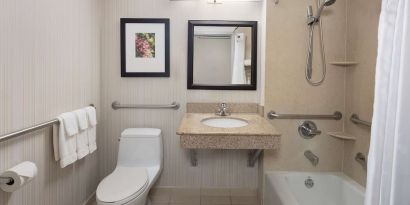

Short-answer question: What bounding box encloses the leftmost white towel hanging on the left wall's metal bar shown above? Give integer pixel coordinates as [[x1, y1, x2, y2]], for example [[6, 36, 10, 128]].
[[53, 113, 77, 168]]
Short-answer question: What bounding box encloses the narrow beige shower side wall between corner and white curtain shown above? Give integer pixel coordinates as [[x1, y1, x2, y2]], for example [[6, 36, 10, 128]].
[[343, 0, 381, 185]]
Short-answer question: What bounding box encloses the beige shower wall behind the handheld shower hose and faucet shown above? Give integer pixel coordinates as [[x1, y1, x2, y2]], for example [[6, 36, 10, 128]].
[[264, 0, 346, 171]]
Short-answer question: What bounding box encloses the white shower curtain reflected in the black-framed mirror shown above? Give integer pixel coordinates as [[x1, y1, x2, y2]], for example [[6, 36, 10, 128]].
[[231, 33, 246, 84]]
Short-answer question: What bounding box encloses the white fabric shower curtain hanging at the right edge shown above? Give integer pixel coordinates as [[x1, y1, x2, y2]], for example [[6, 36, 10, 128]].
[[366, 0, 410, 205]]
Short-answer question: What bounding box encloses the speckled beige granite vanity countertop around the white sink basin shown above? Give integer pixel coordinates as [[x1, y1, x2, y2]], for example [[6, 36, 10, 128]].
[[177, 113, 281, 149]]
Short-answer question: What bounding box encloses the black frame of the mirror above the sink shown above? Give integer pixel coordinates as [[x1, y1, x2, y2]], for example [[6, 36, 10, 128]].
[[187, 20, 258, 90]]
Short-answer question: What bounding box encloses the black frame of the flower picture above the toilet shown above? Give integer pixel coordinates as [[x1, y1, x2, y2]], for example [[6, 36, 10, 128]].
[[120, 18, 170, 77]]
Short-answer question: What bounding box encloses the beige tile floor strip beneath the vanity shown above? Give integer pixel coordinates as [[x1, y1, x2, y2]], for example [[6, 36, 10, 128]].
[[89, 188, 260, 205]]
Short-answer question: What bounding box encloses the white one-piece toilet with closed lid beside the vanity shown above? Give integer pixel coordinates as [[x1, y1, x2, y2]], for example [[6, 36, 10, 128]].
[[96, 128, 163, 205]]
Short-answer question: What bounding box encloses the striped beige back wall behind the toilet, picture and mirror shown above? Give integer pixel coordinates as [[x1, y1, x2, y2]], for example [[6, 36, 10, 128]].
[[99, 0, 263, 187]]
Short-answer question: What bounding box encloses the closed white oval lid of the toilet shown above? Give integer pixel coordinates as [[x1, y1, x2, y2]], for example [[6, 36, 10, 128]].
[[96, 167, 148, 203]]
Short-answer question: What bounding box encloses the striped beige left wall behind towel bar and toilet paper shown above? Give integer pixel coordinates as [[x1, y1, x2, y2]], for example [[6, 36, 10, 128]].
[[0, 0, 100, 205]]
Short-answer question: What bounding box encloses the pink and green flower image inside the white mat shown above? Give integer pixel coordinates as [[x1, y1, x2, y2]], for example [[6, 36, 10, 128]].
[[135, 33, 155, 58]]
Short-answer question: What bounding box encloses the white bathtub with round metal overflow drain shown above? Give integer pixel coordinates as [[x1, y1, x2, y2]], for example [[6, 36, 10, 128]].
[[264, 172, 365, 205]]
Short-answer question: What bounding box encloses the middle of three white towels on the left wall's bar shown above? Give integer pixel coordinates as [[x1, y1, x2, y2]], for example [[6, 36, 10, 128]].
[[73, 109, 90, 159]]
